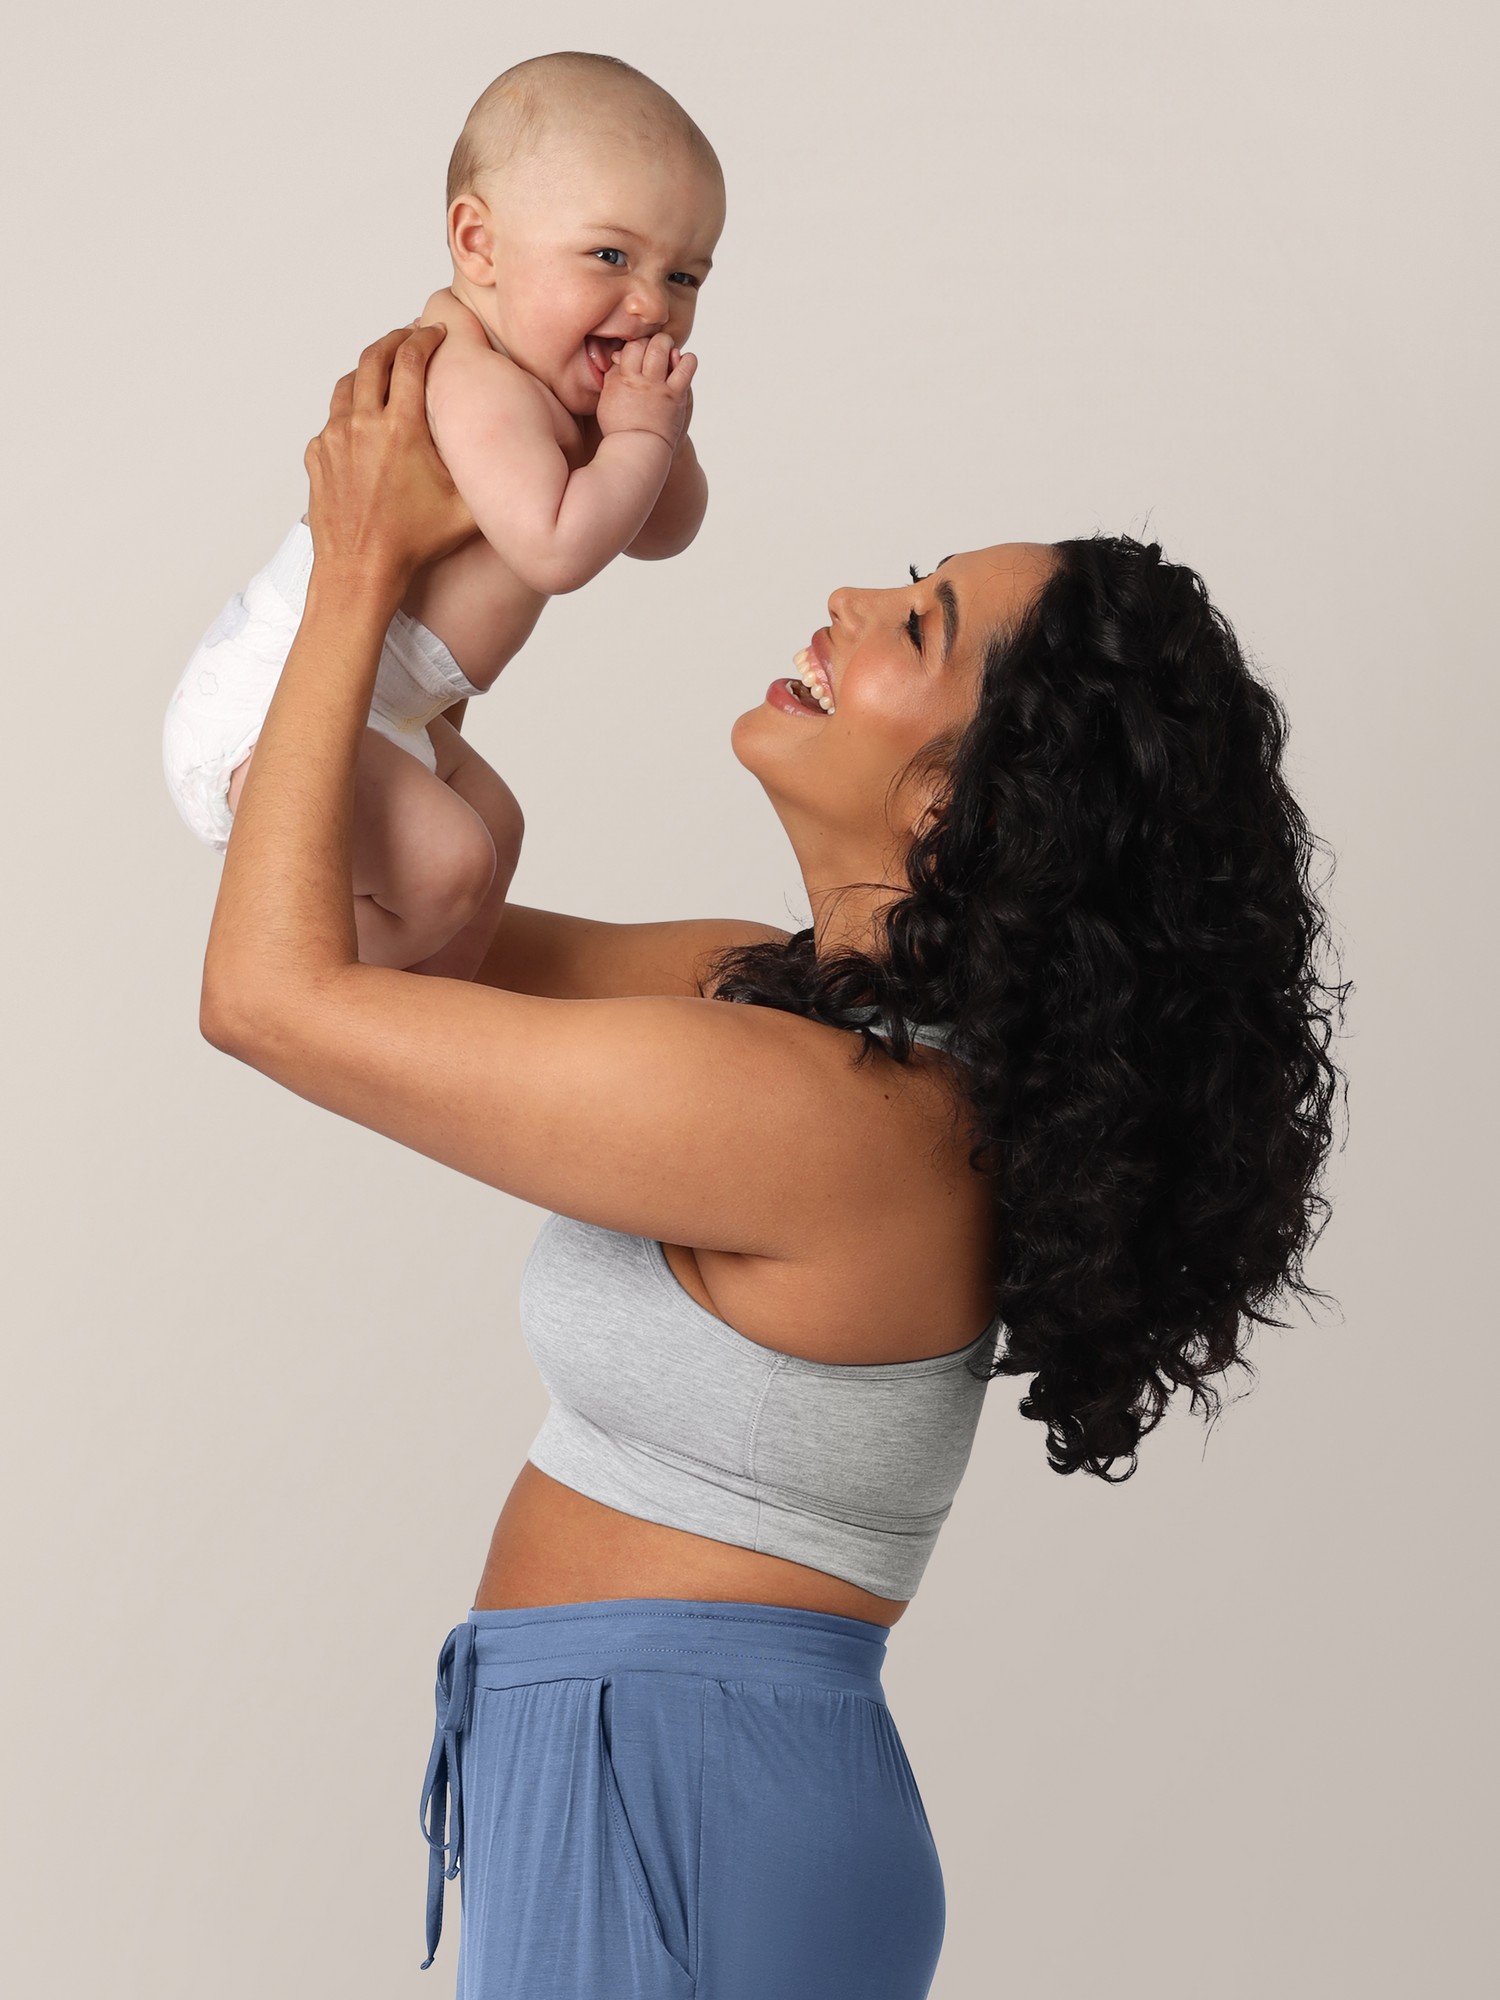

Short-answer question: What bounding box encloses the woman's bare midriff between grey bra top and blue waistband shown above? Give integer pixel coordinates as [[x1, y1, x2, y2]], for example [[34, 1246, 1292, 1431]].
[[474, 1462, 906, 1624]]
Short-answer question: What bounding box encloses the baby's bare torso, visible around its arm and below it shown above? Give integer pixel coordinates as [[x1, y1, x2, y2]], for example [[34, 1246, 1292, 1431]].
[[402, 290, 598, 688]]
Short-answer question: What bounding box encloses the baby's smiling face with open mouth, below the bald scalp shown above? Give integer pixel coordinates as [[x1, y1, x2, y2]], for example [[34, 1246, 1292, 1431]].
[[472, 138, 724, 416]]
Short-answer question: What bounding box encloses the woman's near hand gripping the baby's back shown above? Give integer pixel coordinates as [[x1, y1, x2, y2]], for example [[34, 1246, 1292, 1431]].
[[304, 326, 476, 610]]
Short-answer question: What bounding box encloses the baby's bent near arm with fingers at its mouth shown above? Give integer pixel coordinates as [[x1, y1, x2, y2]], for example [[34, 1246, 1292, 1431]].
[[428, 316, 694, 596]]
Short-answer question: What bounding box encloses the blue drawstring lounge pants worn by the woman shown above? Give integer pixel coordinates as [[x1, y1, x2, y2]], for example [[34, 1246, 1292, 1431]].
[[422, 1598, 944, 2000]]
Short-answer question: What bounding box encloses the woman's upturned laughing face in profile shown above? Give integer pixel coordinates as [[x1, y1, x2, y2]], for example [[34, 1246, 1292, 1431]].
[[732, 542, 1052, 880]]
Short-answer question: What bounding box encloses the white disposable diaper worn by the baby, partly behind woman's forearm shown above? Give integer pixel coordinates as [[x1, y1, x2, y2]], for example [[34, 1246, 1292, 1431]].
[[162, 522, 480, 854]]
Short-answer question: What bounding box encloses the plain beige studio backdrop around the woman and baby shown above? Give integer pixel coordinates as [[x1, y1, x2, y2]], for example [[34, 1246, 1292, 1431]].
[[0, 0, 1500, 2000]]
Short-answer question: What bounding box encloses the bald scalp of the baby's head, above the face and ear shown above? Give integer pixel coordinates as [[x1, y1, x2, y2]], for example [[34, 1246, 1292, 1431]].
[[448, 50, 724, 208]]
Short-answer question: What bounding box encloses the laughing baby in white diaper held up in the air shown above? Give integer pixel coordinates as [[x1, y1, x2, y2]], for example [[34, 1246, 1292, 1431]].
[[162, 54, 724, 978]]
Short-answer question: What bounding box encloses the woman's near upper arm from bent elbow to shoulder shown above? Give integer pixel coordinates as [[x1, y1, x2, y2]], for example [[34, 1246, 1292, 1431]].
[[220, 964, 910, 1258]]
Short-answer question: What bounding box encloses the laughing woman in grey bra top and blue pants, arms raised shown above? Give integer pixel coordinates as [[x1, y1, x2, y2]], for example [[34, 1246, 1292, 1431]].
[[202, 328, 1336, 2000]]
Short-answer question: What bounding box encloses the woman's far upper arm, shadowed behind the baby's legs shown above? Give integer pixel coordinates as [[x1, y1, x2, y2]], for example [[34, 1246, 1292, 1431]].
[[476, 904, 786, 1000]]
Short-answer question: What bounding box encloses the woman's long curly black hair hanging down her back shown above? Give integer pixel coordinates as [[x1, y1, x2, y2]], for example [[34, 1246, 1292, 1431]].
[[710, 536, 1346, 1480]]
